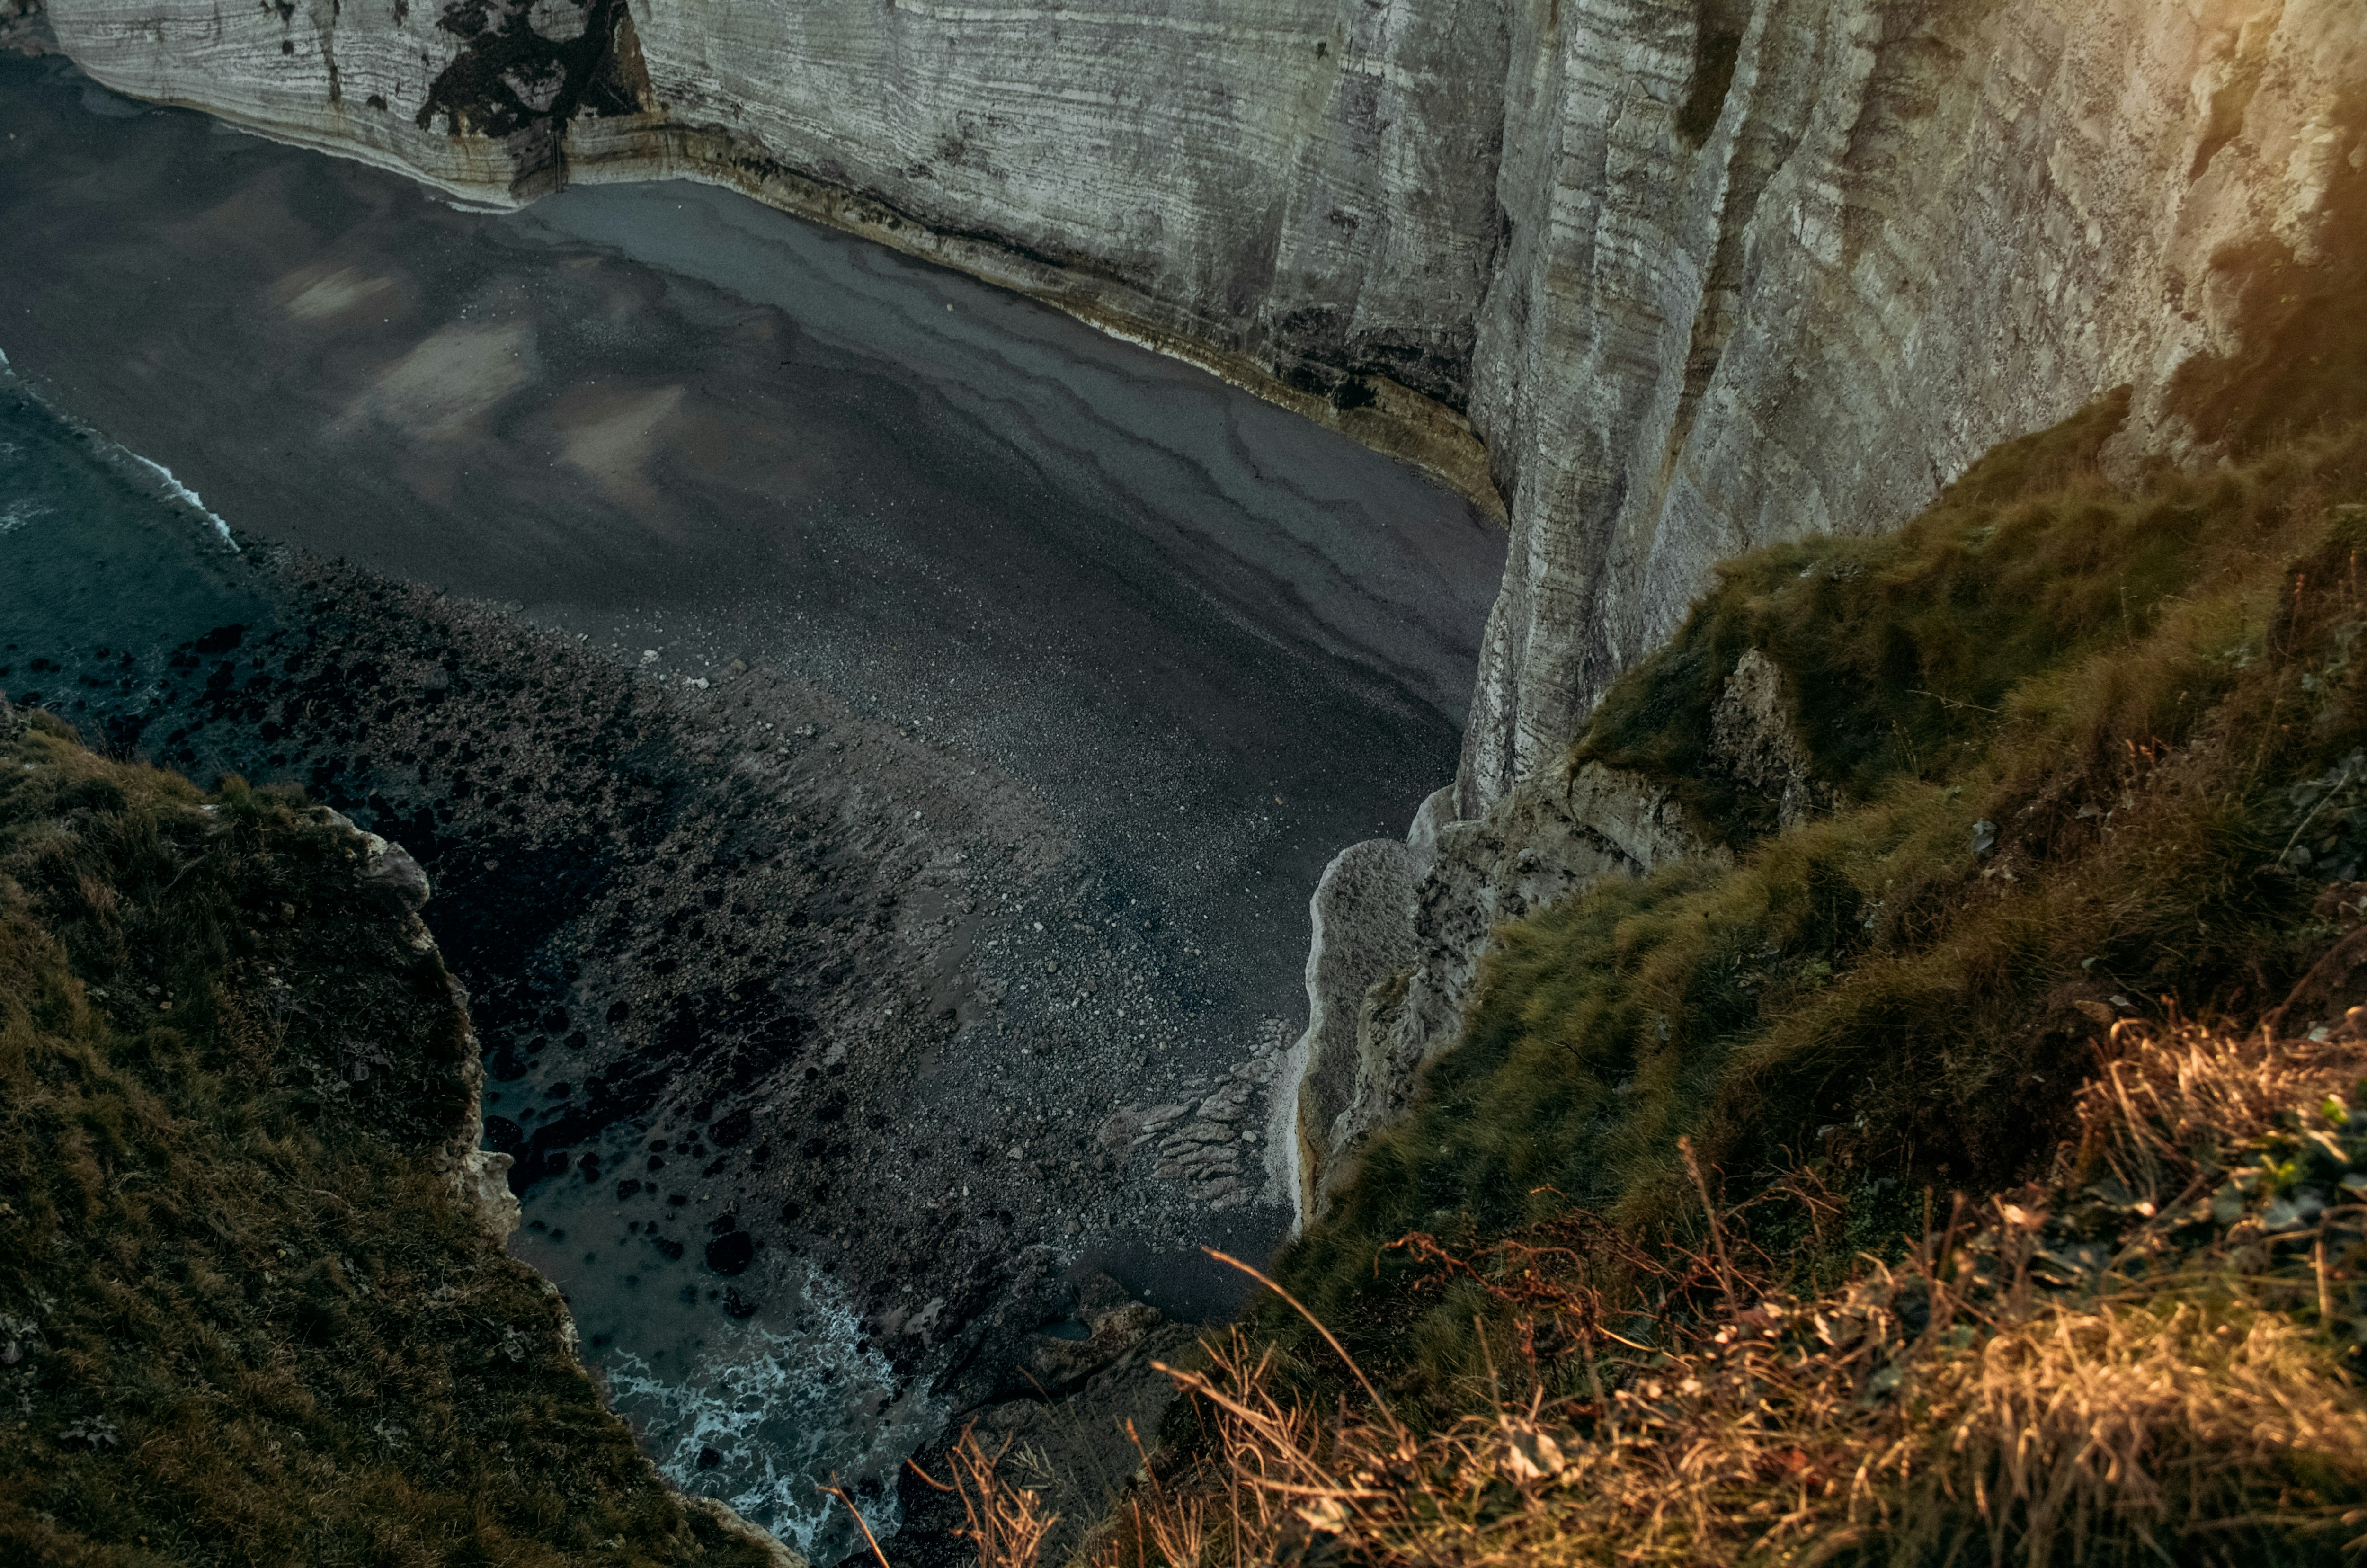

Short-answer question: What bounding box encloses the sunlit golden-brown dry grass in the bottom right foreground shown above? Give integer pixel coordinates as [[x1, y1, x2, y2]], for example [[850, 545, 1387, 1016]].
[[914, 1014, 2367, 1568]]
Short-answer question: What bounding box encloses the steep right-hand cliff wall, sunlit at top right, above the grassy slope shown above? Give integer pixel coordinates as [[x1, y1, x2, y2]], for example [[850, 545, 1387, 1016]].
[[1460, 0, 2367, 815]]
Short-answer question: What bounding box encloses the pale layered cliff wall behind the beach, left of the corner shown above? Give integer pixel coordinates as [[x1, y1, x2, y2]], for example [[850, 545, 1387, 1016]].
[[37, 0, 1505, 485]]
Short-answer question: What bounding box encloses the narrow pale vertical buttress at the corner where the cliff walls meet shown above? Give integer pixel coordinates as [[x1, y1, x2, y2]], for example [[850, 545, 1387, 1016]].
[[1463, 2, 1780, 815]]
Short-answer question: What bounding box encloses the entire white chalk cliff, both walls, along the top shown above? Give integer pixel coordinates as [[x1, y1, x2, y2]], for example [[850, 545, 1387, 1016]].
[[50, 0, 2367, 1212]]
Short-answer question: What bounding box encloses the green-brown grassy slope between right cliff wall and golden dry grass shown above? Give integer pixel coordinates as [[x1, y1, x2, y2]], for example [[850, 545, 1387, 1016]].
[[1264, 83, 2367, 1419]]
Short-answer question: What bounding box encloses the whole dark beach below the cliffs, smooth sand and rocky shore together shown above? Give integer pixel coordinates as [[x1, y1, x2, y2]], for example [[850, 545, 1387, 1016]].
[[0, 62, 1503, 1563]]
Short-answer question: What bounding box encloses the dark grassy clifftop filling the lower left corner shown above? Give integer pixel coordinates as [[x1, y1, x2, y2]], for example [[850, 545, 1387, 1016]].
[[0, 708, 757, 1566]]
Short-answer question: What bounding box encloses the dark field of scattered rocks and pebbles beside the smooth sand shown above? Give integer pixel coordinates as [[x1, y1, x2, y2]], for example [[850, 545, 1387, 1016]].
[[0, 559, 1292, 1563]]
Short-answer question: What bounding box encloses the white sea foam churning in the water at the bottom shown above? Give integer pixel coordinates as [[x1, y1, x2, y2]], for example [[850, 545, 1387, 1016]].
[[606, 1274, 944, 1561]]
